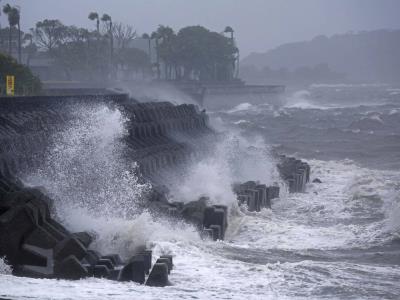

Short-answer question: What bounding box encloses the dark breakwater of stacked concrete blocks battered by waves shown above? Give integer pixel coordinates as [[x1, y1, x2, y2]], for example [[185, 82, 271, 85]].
[[0, 95, 309, 286]]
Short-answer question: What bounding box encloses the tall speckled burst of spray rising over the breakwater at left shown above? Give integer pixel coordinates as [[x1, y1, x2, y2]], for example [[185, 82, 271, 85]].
[[27, 104, 149, 217]]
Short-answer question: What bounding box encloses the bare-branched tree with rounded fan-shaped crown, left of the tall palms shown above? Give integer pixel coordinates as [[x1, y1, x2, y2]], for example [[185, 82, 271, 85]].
[[34, 19, 67, 54]]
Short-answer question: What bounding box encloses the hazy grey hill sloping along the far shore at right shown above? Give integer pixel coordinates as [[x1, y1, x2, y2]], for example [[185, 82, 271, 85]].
[[241, 30, 400, 83]]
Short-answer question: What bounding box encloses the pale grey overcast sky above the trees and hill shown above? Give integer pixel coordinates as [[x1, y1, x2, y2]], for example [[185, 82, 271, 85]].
[[1, 0, 400, 57]]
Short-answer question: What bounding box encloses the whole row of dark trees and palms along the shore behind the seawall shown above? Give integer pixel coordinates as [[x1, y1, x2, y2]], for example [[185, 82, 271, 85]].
[[0, 4, 239, 81]]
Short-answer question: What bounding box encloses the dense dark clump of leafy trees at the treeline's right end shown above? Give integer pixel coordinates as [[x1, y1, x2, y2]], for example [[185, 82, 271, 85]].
[[144, 25, 239, 81]]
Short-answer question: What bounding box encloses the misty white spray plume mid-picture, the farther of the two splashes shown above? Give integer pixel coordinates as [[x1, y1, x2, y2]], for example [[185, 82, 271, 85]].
[[172, 132, 279, 207]]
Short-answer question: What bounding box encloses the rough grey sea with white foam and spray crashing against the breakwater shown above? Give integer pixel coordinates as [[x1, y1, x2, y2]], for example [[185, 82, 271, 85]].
[[0, 84, 400, 300]]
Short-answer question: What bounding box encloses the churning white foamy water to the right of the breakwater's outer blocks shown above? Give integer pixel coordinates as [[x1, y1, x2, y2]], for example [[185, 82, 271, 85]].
[[233, 160, 400, 250]]
